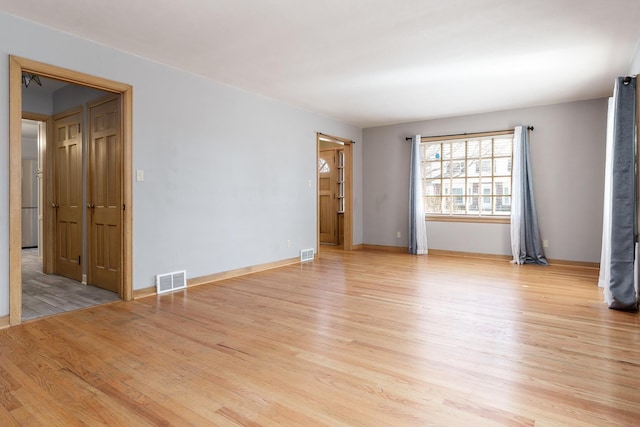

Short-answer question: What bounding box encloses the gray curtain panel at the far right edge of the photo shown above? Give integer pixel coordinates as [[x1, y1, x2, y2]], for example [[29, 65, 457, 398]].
[[609, 77, 638, 311]]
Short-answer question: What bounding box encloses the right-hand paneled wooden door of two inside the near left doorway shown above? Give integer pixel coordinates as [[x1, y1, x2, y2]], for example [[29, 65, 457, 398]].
[[87, 97, 124, 293]]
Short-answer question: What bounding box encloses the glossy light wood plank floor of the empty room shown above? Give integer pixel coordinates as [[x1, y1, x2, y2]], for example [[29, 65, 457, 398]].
[[0, 248, 640, 426]]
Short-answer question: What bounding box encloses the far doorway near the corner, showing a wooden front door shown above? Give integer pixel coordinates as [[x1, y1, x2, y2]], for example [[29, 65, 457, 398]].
[[316, 133, 354, 251]]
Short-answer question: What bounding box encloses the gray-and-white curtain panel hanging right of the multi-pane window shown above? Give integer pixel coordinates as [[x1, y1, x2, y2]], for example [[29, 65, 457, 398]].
[[513, 126, 548, 265]]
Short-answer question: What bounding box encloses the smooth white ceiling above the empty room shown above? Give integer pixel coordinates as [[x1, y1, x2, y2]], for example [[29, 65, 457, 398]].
[[5, 0, 640, 127]]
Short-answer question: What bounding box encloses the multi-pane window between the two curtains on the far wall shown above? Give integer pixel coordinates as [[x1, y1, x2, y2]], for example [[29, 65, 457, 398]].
[[421, 131, 513, 219]]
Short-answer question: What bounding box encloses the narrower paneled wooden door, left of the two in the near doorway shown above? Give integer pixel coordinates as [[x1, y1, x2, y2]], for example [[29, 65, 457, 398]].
[[52, 112, 82, 281]]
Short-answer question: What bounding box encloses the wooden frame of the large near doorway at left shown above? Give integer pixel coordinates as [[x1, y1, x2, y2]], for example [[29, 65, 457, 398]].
[[9, 55, 133, 326]]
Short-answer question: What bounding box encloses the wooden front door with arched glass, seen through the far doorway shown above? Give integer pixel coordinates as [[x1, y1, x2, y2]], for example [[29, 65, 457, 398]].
[[318, 150, 338, 245]]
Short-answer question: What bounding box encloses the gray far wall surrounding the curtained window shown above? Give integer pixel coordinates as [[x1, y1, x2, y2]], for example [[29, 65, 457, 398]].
[[363, 99, 607, 262]]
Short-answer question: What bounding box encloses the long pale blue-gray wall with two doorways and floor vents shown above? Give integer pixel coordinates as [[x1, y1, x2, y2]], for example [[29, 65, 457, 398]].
[[0, 13, 363, 316]]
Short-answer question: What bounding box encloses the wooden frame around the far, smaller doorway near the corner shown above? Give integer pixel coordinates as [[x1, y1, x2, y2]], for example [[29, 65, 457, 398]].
[[316, 132, 353, 253]]
